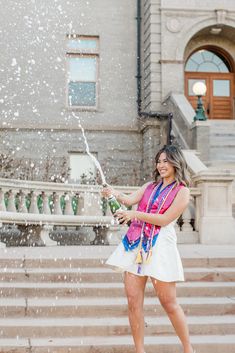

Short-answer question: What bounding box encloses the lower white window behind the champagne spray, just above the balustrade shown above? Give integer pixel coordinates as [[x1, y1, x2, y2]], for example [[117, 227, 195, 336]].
[[69, 152, 96, 184]]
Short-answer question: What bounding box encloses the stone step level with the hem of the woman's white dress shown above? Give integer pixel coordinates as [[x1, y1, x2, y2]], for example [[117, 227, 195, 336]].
[[0, 266, 235, 283]]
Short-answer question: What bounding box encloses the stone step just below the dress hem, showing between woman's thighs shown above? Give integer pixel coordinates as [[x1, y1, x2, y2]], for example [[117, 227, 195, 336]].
[[0, 281, 235, 298]]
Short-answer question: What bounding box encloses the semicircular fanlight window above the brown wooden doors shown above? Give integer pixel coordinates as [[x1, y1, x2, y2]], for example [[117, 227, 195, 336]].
[[185, 49, 230, 73]]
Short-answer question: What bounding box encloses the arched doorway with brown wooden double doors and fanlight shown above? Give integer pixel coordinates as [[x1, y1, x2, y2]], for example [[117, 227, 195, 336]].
[[185, 47, 235, 119]]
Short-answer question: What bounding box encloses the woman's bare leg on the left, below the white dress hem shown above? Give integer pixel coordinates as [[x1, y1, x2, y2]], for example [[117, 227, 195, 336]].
[[124, 272, 147, 353]]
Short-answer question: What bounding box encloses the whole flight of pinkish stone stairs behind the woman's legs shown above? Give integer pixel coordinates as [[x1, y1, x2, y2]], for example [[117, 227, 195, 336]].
[[0, 244, 235, 353]]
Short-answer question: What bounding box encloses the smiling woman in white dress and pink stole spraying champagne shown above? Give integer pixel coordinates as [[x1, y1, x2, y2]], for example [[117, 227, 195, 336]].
[[102, 145, 195, 353]]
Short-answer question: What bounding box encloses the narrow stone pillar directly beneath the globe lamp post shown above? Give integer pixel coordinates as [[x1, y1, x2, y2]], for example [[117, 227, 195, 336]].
[[191, 120, 210, 162]]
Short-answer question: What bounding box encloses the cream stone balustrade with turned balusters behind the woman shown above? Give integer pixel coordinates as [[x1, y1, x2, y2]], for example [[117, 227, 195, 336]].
[[0, 178, 200, 245]]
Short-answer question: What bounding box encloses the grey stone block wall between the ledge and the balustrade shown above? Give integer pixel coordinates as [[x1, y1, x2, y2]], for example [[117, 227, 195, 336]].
[[0, 129, 142, 185]]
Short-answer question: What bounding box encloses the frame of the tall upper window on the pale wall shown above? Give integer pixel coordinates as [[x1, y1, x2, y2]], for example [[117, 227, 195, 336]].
[[65, 35, 100, 111]]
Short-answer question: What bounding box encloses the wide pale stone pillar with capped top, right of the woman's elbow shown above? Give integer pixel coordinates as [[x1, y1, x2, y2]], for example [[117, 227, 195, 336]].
[[193, 171, 235, 245]]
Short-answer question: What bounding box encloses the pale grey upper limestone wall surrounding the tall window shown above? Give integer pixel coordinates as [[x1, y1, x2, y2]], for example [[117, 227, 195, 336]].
[[0, 0, 136, 129]]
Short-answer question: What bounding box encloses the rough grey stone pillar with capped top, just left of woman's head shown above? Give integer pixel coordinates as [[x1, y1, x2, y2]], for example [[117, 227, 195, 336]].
[[140, 118, 168, 182]]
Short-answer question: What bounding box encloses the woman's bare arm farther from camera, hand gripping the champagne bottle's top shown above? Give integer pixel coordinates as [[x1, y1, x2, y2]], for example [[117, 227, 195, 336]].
[[101, 182, 150, 206]]
